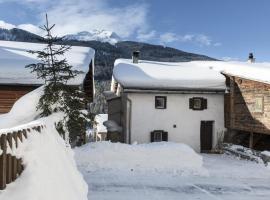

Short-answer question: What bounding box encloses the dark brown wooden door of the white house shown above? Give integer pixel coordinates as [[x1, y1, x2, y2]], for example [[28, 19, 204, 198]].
[[201, 121, 214, 152]]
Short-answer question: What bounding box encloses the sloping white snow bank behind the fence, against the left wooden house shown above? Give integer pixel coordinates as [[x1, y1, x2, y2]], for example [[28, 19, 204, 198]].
[[0, 86, 43, 129]]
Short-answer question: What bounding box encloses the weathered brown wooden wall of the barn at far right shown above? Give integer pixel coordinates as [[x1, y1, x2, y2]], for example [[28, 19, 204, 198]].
[[225, 75, 270, 134]]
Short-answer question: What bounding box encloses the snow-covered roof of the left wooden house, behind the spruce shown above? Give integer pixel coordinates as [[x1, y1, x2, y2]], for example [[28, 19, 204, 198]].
[[0, 40, 95, 85]]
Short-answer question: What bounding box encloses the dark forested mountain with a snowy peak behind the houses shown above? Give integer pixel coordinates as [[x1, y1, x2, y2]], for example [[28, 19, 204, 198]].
[[0, 28, 215, 81]]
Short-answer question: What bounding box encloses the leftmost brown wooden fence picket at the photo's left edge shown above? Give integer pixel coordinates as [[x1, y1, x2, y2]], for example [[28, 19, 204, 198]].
[[0, 134, 7, 190]]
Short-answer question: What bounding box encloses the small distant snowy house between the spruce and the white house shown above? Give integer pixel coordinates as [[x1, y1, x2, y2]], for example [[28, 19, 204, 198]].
[[94, 114, 108, 141]]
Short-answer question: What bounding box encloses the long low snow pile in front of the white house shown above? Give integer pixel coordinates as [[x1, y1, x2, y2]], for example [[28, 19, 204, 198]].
[[75, 142, 207, 175]]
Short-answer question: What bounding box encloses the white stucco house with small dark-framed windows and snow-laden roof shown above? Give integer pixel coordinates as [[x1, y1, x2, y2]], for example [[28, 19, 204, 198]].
[[105, 55, 226, 152]]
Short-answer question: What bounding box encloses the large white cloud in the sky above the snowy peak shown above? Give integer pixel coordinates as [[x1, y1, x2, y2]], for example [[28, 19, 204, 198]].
[[0, 0, 148, 38]]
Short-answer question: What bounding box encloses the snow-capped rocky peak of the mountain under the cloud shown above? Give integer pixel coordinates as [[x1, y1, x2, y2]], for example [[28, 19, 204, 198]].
[[64, 30, 121, 44]]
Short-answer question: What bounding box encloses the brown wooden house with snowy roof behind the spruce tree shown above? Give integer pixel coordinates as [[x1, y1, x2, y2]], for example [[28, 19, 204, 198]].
[[0, 41, 95, 114]]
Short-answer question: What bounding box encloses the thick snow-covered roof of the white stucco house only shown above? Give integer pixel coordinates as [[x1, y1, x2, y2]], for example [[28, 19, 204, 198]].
[[113, 59, 226, 90]]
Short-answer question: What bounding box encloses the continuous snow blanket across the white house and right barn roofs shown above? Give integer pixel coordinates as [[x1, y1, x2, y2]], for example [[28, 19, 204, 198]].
[[113, 59, 270, 90]]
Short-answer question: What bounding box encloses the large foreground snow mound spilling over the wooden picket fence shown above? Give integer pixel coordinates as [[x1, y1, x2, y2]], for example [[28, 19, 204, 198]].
[[0, 115, 88, 200]]
